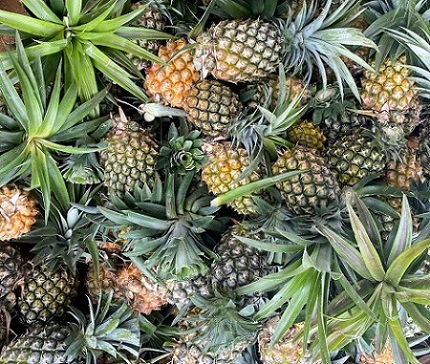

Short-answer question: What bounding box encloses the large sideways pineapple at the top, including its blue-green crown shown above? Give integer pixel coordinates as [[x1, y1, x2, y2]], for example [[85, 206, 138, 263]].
[[195, 0, 375, 97]]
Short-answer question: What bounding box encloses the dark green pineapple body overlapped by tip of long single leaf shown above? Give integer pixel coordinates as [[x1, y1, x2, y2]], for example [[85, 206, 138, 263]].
[[272, 146, 340, 215]]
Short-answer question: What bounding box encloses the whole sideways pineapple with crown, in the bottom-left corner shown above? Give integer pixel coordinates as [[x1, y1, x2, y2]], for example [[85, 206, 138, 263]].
[[0, 294, 140, 364]]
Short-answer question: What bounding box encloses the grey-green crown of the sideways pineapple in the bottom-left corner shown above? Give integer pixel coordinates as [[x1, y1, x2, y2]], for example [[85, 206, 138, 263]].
[[64, 292, 140, 364]]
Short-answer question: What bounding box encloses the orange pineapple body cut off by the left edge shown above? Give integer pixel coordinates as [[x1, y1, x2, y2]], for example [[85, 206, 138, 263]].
[[0, 185, 38, 241]]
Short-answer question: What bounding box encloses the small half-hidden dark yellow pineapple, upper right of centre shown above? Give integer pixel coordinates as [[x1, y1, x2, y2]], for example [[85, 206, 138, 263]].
[[287, 120, 326, 150]]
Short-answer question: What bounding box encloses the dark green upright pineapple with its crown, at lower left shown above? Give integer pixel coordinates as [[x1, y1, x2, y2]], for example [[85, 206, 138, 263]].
[[17, 185, 100, 325]]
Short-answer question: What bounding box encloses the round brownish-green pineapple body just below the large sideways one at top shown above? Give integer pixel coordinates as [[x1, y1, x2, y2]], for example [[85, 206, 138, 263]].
[[184, 80, 242, 137]]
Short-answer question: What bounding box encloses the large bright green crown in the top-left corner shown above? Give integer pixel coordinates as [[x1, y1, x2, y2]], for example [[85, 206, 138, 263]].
[[0, 0, 171, 104]]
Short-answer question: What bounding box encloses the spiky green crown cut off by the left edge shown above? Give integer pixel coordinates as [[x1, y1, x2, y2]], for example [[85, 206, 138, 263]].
[[0, 34, 107, 219]]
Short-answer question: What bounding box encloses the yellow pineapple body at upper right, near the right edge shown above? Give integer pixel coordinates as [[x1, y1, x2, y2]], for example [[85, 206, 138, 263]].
[[361, 56, 422, 135]]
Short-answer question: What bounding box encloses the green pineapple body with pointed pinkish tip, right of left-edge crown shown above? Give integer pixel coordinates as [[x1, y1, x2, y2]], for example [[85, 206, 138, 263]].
[[100, 110, 158, 195]]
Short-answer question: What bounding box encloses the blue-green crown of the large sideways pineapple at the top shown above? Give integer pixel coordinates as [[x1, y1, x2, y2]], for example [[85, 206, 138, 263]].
[[276, 0, 376, 100]]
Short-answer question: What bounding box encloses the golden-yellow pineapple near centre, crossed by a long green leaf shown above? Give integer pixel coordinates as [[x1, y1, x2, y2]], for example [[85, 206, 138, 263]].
[[201, 142, 260, 215]]
